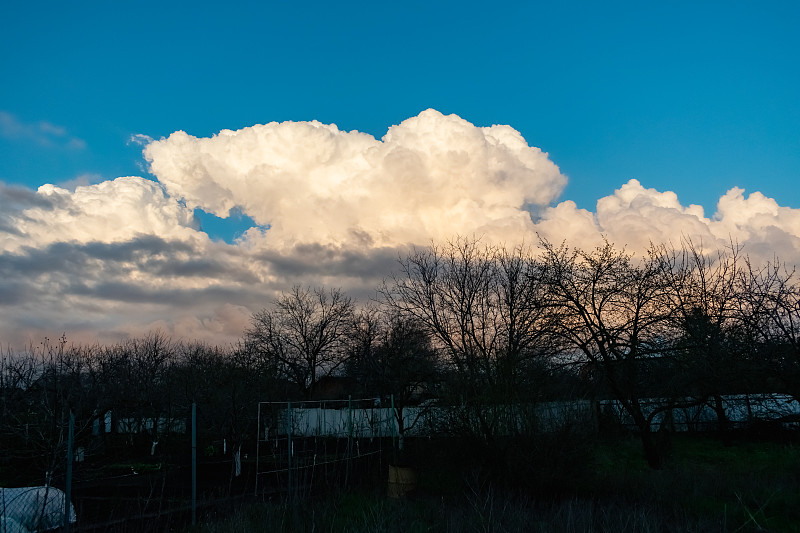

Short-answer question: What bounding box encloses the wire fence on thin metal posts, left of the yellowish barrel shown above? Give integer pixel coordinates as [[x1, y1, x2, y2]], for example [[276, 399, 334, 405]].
[[0, 399, 393, 533]]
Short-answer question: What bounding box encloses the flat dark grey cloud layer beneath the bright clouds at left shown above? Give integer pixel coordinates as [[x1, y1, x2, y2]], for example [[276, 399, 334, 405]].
[[0, 236, 412, 344]]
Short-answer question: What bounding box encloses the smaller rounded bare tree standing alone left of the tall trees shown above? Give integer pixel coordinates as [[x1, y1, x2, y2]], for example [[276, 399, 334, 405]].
[[245, 286, 354, 398]]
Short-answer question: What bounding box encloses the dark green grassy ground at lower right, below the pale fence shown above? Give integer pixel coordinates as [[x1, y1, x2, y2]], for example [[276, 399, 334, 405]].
[[187, 435, 800, 533]]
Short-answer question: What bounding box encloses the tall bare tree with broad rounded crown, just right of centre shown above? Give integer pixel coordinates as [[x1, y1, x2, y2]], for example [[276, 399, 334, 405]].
[[381, 239, 551, 443]]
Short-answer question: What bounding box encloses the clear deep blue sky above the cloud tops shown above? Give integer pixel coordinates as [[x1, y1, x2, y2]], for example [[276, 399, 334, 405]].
[[0, 1, 800, 229]]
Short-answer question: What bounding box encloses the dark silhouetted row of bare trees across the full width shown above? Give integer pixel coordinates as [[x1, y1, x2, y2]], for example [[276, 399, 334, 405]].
[[0, 239, 800, 478]]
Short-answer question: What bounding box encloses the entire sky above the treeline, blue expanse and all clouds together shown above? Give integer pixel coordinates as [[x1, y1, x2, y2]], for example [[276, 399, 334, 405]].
[[0, 0, 800, 344]]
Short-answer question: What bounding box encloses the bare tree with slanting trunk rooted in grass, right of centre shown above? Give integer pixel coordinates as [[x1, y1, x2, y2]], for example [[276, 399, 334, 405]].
[[541, 240, 673, 468]]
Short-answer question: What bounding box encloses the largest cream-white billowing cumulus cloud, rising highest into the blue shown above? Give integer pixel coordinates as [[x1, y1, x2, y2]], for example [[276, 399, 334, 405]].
[[144, 110, 566, 248]]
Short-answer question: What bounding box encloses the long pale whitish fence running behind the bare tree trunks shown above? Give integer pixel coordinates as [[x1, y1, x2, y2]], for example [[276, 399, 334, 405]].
[[274, 394, 800, 440]]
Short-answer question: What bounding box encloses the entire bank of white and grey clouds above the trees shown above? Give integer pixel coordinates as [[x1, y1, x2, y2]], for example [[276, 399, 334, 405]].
[[0, 110, 800, 346]]
